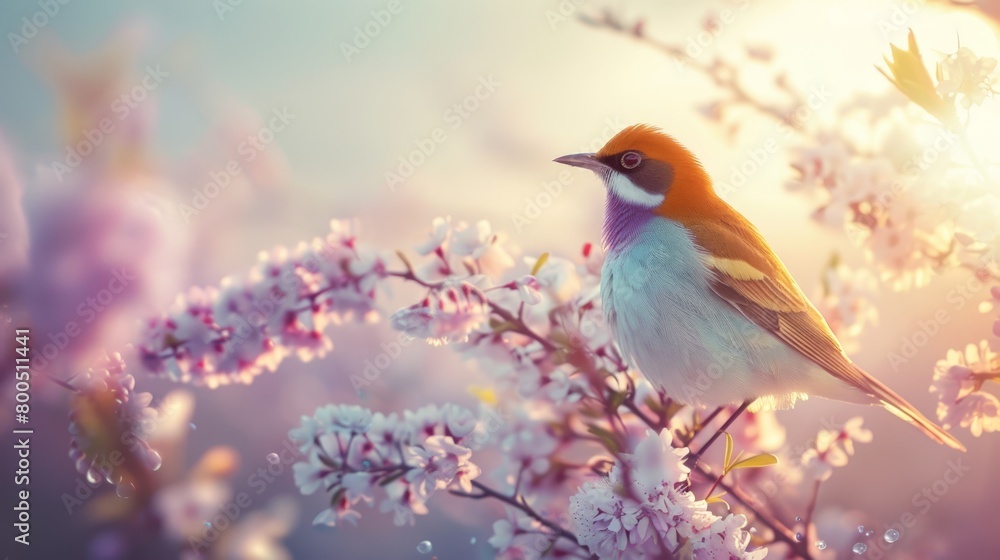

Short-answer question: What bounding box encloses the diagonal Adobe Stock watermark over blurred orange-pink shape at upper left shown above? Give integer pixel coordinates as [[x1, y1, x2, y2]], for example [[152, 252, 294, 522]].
[[50, 64, 170, 183]]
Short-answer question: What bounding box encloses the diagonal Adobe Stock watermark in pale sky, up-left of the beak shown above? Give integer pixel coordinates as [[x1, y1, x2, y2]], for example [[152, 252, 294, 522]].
[[385, 74, 501, 192]]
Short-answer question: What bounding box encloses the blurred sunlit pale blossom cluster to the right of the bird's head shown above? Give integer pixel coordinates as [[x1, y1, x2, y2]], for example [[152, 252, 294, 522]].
[[789, 116, 957, 289]]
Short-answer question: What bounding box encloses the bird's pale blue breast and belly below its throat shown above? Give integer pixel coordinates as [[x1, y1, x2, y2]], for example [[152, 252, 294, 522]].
[[601, 216, 813, 406]]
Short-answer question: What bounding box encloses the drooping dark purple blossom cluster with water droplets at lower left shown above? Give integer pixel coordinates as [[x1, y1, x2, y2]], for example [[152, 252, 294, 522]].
[[69, 353, 163, 497]]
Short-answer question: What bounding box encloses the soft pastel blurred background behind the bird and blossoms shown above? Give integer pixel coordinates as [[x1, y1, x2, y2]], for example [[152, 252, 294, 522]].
[[0, 0, 1000, 559]]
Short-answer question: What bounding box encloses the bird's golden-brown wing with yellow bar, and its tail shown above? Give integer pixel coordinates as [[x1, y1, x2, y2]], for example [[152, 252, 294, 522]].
[[685, 203, 964, 450]]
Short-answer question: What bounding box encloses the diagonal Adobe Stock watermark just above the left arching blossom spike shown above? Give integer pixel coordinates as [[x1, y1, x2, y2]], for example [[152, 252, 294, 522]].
[[178, 106, 295, 224]]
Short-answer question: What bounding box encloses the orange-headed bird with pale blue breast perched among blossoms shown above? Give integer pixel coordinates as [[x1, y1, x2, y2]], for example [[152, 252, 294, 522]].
[[554, 124, 965, 451]]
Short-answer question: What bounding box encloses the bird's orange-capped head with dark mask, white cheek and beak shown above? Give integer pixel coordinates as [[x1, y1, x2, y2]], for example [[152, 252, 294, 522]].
[[555, 124, 714, 216]]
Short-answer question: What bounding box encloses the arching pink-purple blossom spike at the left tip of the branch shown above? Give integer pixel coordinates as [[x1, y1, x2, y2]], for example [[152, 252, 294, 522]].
[[140, 221, 385, 387]]
